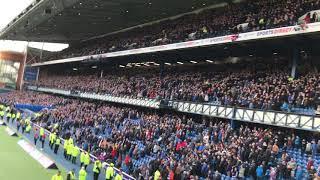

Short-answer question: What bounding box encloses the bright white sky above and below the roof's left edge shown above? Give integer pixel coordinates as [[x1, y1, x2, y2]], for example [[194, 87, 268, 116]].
[[0, 0, 68, 52]]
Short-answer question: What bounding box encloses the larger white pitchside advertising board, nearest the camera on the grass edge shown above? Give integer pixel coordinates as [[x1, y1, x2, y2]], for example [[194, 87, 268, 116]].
[[18, 140, 57, 169]]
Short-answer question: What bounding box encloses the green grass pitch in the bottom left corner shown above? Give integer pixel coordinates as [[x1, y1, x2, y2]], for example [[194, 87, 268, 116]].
[[0, 126, 65, 180]]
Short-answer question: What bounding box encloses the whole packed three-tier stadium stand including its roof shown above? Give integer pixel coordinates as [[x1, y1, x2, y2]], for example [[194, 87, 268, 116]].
[[0, 0, 320, 180]]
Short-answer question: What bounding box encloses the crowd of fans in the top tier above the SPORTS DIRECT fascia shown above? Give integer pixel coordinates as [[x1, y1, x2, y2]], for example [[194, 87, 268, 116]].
[[42, 0, 320, 60]]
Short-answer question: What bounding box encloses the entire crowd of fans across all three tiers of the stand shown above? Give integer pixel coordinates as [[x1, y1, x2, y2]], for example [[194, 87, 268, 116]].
[[0, 0, 320, 180]]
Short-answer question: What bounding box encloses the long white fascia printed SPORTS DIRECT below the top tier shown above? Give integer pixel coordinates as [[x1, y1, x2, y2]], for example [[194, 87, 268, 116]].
[[31, 22, 320, 66]]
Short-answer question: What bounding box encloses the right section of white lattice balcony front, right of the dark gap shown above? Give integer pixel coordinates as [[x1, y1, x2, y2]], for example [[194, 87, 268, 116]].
[[168, 101, 320, 131]]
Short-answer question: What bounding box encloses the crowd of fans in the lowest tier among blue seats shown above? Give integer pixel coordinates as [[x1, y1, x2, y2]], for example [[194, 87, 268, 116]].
[[4, 94, 320, 180]]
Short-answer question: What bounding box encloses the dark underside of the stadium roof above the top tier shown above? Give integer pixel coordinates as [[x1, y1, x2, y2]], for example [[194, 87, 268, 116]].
[[0, 0, 228, 42]]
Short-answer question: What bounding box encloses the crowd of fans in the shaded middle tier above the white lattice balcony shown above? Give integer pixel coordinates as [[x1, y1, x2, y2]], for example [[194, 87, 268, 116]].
[[38, 60, 320, 111]]
